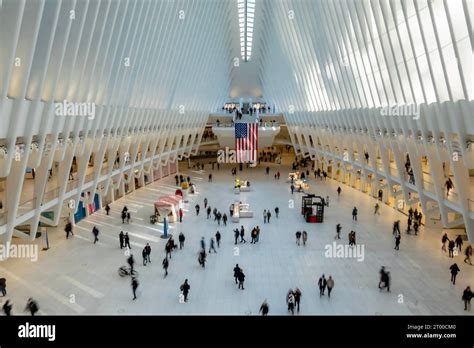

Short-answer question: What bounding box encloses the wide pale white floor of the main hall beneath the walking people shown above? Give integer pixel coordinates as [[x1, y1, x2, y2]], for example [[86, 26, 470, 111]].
[[0, 156, 474, 315]]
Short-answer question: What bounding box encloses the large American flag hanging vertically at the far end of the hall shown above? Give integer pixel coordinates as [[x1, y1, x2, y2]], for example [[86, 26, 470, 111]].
[[235, 123, 258, 163]]
